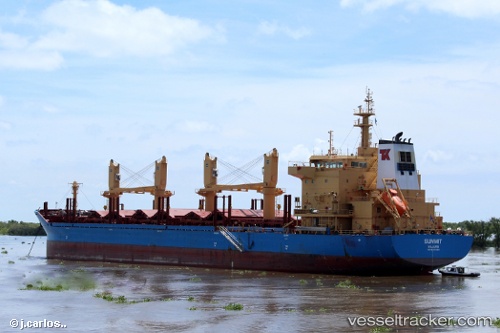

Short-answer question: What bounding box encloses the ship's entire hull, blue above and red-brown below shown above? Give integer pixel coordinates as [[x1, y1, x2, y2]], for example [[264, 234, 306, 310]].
[[35, 212, 472, 275]]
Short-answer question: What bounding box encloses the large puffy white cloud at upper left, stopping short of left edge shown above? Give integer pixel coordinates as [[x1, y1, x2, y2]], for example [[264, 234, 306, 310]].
[[35, 0, 214, 57]]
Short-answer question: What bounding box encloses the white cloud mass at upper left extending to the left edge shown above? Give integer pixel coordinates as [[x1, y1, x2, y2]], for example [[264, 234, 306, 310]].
[[0, 0, 224, 70]]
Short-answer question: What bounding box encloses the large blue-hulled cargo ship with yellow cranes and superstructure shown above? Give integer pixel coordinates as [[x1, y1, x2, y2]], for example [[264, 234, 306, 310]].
[[35, 90, 472, 275]]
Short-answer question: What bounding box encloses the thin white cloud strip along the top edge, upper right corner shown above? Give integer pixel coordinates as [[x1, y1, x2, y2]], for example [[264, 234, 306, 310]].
[[340, 0, 500, 18]]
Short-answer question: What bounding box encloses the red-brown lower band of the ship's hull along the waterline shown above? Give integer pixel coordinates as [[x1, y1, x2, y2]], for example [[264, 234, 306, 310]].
[[47, 241, 433, 275]]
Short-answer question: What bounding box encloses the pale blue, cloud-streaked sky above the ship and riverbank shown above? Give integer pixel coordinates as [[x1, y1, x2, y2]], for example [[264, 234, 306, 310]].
[[0, 0, 500, 222]]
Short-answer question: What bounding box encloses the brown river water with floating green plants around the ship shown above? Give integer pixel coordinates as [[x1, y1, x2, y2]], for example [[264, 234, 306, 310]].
[[0, 236, 500, 333]]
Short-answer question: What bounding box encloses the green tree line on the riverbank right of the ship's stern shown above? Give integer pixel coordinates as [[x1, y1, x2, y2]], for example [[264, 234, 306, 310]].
[[443, 217, 500, 249]]
